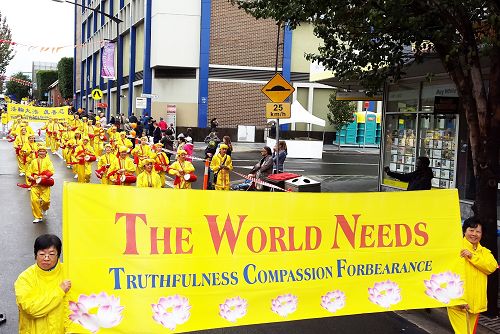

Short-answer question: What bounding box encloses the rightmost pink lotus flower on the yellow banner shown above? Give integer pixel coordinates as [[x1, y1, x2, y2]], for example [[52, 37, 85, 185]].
[[424, 271, 464, 304]]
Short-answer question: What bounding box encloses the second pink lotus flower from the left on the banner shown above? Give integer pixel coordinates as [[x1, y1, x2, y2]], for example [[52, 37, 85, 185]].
[[151, 295, 191, 330]]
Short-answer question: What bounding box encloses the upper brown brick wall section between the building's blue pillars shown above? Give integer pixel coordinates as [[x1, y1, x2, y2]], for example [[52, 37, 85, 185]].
[[210, 0, 283, 68]]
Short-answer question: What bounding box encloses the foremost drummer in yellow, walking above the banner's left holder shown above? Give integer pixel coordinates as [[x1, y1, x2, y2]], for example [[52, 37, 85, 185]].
[[26, 144, 54, 224]]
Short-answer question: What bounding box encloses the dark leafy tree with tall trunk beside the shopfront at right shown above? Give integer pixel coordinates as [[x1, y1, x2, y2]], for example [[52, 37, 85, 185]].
[[233, 0, 500, 315]]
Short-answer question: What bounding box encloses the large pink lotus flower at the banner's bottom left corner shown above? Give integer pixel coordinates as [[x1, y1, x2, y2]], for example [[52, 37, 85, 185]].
[[69, 292, 123, 333]]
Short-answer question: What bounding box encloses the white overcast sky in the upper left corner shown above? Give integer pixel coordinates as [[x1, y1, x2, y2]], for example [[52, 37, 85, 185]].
[[0, 0, 74, 75]]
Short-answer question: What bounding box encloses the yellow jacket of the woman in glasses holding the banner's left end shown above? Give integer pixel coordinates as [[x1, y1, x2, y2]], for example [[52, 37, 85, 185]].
[[14, 263, 69, 334]]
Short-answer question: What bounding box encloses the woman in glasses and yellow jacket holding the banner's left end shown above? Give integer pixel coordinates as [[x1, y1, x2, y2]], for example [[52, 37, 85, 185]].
[[14, 234, 71, 334]]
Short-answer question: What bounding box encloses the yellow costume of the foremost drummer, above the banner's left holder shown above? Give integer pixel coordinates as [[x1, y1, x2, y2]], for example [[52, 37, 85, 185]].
[[26, 156, 54, 219]]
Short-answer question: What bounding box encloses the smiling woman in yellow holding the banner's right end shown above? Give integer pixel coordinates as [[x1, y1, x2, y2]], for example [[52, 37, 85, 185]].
[[448, 216, 498, 334]]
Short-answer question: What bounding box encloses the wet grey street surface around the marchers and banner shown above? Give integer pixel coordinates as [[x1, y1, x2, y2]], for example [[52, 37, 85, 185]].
[[0, 137, 489, 334]]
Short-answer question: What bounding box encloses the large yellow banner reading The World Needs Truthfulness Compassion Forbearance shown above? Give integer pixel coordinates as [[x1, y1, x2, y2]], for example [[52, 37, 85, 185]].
[[63, 183, 464, 333]]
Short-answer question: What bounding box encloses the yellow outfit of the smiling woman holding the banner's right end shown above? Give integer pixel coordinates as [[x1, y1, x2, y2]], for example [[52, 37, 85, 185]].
[[448, 237, 498, 334]]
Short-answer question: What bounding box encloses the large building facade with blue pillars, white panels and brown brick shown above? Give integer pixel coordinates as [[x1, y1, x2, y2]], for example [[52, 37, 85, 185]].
[[74, 0, 331, 131]]
